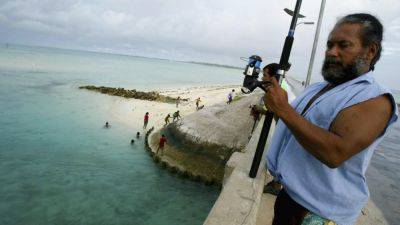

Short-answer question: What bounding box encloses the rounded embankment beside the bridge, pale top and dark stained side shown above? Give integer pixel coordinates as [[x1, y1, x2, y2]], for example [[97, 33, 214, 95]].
[[148, 93, 262, 184]]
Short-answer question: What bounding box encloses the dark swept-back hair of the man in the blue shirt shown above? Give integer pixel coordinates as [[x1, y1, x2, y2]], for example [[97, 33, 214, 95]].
[[335, 13, 383, 70]]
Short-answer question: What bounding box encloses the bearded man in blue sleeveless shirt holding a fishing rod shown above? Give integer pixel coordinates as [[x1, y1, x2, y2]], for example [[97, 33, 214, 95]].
[[264, 14, 398, 225]]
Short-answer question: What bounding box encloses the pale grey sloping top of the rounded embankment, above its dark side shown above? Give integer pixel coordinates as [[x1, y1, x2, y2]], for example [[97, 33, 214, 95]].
[[178, 91, 263, 149]]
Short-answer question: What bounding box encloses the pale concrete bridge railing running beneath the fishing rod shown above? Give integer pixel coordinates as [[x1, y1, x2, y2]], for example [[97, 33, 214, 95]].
[[204, 117, 275, 225]]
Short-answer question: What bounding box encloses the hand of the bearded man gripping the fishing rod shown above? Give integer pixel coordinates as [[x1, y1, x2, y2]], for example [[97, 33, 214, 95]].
[[263, 76, 291, 117]]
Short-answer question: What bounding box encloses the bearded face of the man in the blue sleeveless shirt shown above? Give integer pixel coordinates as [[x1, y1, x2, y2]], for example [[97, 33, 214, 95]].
[[322, 24, 371, 85]]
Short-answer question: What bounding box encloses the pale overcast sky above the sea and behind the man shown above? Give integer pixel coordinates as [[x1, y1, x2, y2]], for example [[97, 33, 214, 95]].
[[0, 0, 400, 89]]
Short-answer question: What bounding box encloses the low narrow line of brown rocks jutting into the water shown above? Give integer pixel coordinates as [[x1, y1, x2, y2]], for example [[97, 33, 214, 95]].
[[79, 85, 189, 103]]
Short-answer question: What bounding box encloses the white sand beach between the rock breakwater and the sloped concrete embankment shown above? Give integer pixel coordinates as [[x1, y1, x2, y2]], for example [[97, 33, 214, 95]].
[[106, 85, 241, 132]]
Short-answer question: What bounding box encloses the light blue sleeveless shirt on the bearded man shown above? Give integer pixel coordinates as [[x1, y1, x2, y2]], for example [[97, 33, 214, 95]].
[[267, 72, 398, 225]]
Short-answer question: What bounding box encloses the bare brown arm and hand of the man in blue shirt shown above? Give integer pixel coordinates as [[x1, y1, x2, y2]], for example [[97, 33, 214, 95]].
[[264, 78, 393, 168]]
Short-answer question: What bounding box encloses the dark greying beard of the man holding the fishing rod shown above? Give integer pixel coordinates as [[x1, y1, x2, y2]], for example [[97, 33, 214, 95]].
[[322, 56, 366, 85]]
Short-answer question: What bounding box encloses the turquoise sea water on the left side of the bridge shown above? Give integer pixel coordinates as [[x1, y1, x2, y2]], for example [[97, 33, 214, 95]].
[[0, 45, 242, 225]]
